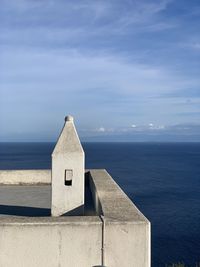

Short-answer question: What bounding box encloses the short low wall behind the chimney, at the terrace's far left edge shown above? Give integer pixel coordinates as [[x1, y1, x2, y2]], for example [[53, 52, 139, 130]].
[[0, 170, 51, 185]]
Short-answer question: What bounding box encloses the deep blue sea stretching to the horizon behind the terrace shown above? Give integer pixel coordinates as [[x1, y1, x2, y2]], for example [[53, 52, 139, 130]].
[[0, 143, 200, 267]]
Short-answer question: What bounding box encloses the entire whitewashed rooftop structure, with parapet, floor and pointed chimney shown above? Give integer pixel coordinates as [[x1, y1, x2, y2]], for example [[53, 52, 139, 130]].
[[0, 116, 151, 267]]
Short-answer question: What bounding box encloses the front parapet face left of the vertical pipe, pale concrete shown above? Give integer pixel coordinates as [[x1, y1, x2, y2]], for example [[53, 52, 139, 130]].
[[0, 217, 102, 267]]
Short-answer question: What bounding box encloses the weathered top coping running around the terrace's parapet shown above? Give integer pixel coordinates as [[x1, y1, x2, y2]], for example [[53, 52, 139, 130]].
[[0, 169, 149, 224]]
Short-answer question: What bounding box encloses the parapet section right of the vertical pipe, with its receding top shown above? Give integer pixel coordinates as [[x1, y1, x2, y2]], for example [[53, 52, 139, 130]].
[[90, 170, 151, 267]]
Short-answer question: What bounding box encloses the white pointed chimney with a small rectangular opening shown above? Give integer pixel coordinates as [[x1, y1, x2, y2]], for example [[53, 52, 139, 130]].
[[51, 116, 85, 216]]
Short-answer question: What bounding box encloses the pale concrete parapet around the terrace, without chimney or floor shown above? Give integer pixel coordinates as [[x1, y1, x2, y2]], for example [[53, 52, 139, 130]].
[[0, 170, 150, 267]]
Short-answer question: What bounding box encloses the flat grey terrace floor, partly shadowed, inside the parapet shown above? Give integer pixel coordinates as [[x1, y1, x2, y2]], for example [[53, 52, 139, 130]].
[[0, 185, 96, 217]]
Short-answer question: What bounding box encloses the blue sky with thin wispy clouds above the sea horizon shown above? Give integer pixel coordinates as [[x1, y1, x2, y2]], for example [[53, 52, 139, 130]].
[[0, 0, 200, 142]]
